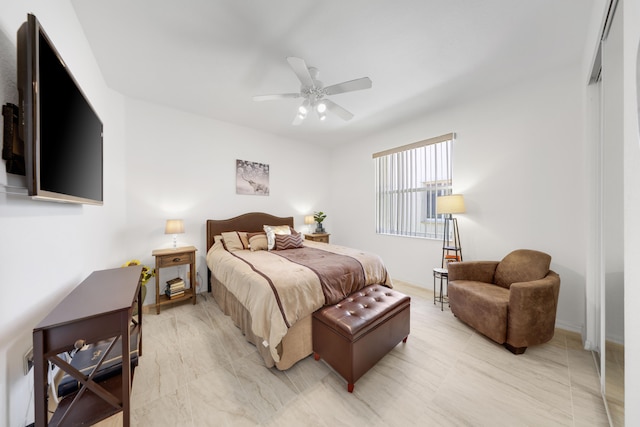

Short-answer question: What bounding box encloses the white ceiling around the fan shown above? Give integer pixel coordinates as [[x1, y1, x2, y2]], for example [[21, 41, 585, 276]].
[[72, 0, 594, 145]]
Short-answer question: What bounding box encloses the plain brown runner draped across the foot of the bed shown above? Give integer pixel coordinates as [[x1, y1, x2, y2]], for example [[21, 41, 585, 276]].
[[271, 247, 366, 305]]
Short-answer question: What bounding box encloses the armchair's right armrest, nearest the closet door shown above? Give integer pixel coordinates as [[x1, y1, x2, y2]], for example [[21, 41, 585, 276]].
[[507, 271, 560, 347]]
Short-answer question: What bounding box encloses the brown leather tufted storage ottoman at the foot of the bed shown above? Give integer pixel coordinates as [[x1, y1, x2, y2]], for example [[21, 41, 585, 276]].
[[312, 285, 411, 393]]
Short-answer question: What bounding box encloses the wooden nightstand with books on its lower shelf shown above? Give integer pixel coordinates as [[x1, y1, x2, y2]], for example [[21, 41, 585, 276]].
[[151, 246, 197, 314]]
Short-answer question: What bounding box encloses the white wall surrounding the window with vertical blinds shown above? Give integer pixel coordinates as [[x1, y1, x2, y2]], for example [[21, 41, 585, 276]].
[[331, 64, 586, 331]]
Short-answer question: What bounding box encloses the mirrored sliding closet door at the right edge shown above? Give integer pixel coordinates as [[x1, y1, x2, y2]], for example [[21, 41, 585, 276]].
[[601, 1, 625, 425]]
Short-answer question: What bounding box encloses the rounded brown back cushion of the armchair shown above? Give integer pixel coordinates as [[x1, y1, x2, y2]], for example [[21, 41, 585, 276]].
[[494, 249, 551, 289]]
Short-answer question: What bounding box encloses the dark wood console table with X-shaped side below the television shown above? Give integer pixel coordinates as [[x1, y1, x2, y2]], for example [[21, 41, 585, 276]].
[[33, 266, 142, 426]]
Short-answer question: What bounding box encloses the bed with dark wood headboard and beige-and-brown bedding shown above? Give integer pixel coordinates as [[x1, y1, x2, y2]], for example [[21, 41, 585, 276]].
[[206, 212, 392, 370]]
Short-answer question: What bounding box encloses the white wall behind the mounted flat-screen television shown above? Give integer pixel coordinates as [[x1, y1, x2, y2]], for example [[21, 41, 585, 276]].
[[0, 0, 126, 426]]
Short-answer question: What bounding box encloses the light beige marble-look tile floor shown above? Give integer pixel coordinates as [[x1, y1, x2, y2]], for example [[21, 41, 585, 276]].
[[101, 282, 608, 427]]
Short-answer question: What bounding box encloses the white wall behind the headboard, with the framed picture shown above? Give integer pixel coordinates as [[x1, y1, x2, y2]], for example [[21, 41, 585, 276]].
[[124, 100, 332, 304]]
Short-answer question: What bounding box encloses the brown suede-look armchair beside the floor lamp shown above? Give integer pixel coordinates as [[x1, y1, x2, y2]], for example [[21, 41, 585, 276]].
[[448, 249, 560, 354]]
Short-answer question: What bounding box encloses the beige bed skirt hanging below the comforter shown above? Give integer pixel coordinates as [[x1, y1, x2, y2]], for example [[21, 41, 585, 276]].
[[211, 274, 313, 371]]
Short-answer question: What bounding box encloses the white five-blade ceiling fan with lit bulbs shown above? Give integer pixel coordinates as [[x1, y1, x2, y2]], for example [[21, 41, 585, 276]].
[[253, 56, 371, 125]]
